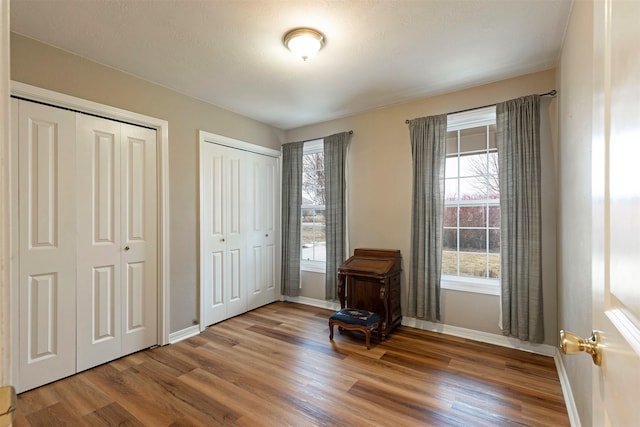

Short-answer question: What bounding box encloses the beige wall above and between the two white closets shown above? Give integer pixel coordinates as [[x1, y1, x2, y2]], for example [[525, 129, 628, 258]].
[[11, 34, 282, 332]]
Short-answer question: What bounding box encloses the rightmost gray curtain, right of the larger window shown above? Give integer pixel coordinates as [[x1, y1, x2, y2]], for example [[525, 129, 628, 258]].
[[496, 95, 544, 343]]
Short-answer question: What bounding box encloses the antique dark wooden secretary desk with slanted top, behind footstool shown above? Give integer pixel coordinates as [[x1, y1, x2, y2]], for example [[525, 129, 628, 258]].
[[338, 248, 402, 339]]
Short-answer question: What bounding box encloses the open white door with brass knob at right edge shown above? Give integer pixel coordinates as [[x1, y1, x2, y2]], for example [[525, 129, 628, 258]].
[[592, 0, 640, 426]]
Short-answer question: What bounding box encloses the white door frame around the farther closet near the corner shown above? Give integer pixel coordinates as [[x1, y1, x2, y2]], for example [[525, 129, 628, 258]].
[[198, 130, 282, 332]]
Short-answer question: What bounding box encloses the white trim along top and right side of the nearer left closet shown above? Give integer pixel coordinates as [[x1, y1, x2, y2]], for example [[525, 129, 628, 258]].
[[11, 81, 170, 345]]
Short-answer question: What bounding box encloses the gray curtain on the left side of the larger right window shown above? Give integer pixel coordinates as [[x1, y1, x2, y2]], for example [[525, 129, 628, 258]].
[[407, 114, 447, 322]]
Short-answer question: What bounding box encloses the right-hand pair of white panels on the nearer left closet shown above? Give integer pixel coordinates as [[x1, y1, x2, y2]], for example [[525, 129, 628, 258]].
[[76, 114, 157, 371]]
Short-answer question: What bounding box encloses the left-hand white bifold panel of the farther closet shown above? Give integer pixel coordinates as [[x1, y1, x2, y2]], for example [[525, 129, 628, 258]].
[[200, 142, 250, 328]]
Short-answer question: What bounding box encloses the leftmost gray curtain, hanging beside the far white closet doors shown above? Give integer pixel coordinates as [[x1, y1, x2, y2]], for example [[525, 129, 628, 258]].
[[281, 142, 304, 297]]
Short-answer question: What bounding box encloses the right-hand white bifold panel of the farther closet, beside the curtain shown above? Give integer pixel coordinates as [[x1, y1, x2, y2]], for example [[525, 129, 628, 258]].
[[248, 154, 280, 310]]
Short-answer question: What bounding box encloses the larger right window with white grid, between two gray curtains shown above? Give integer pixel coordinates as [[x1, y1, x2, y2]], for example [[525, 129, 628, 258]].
[[442, 107, 500, 294]]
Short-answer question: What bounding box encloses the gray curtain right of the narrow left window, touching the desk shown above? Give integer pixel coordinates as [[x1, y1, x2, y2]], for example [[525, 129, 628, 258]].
[[324, 132, 351, 300]]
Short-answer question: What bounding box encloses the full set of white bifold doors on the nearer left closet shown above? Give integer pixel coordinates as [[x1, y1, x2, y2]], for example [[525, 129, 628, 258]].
[[12, 99, 158, 392]]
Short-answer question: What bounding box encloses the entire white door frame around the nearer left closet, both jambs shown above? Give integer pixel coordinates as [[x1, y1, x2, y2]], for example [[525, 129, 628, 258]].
[[4, 81, 170, 382]]
